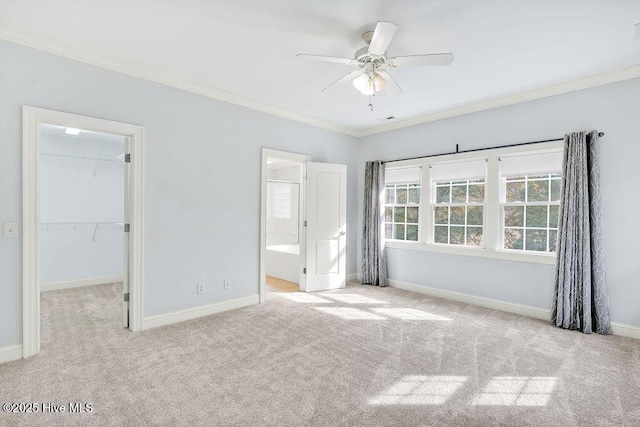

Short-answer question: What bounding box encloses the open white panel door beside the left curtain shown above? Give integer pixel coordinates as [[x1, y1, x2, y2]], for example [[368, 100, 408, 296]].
[[304, 162, 347, 292]]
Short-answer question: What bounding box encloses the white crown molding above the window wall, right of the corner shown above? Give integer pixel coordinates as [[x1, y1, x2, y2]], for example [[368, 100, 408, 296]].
[[356, 64, 640, 138]]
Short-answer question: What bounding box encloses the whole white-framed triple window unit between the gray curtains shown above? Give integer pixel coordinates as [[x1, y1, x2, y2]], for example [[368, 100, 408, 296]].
[[384, 142, 562, 264]]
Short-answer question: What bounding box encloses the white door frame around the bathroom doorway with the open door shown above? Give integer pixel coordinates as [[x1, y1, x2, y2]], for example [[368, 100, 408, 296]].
[[259, 148, 311, 302]]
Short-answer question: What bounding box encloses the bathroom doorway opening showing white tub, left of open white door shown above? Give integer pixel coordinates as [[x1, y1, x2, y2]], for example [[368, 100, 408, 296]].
[[265, 156, 304, 292]]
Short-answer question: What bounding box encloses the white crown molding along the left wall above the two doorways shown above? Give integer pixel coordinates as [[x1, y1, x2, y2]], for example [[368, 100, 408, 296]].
[[0, 26, 356, 136]]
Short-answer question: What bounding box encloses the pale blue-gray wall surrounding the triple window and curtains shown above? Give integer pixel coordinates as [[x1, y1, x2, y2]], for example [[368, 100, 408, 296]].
[[357, 79, 640, 326]]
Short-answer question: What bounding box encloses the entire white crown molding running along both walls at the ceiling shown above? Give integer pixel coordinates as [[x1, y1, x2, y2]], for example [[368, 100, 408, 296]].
[[0, 26, 640, 138]]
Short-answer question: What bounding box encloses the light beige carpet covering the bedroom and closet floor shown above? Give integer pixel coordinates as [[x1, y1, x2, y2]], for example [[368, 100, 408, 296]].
[[0, 285, 640, 426]]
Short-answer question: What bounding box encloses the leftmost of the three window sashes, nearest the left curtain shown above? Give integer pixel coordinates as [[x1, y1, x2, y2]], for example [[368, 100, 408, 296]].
[[384, 168, 421, 242]]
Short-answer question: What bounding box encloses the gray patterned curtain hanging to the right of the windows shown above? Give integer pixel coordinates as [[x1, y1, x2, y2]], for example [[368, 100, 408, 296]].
[[551, 131, 611, 334]]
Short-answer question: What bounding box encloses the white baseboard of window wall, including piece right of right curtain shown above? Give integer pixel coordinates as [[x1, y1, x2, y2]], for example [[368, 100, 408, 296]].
[[389, 280, 640, 339]]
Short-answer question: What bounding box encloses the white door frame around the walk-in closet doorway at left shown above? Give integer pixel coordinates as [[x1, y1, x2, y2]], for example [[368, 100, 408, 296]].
[[22, 105, 144, 358]]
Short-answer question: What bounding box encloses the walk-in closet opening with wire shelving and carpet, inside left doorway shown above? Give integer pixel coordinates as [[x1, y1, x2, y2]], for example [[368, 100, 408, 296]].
[[39, 123, 129, 346]]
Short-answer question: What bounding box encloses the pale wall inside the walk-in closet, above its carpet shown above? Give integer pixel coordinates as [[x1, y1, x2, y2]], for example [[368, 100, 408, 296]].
[[40, 132, 124, 284]]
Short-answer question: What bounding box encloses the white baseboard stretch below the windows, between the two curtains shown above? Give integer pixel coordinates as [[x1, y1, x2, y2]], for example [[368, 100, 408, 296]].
[[389, 280, 551, 320]]
